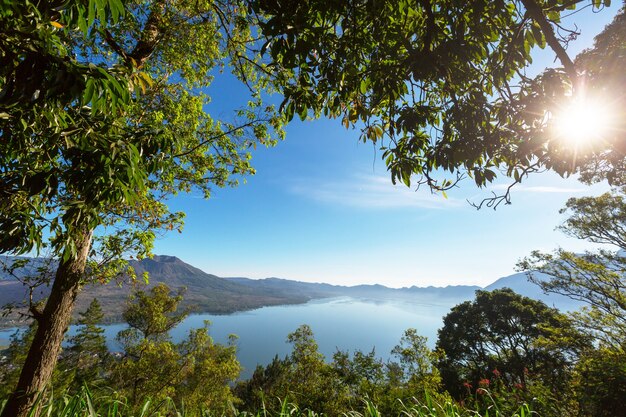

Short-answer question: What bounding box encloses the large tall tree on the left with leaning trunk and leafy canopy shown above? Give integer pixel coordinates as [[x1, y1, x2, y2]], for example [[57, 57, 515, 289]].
[[0, 0, 282, 417]]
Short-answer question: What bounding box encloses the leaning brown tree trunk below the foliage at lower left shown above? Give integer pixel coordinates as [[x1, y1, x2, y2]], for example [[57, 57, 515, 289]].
[[0, 231, 92, 417]]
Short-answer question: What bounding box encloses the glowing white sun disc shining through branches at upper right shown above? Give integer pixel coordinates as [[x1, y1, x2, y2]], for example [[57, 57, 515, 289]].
[[554, 99, 611, 148]]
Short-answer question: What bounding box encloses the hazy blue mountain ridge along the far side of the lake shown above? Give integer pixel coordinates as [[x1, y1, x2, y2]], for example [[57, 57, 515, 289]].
[[0, 255, 576, 327]]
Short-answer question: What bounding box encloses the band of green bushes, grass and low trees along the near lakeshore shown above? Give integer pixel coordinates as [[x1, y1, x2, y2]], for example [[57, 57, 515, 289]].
[[0, 285, 626, 417]]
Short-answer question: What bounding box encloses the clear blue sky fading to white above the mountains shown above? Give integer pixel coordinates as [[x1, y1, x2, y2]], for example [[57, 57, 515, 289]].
[[154, 7, 617, 288]]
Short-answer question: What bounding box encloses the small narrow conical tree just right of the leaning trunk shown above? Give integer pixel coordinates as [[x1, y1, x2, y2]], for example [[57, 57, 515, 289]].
[[60, 298, 109, 387]]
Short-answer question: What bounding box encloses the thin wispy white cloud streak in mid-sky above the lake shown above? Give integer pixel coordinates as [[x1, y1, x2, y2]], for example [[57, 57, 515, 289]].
[[289, 174, 460, 209]]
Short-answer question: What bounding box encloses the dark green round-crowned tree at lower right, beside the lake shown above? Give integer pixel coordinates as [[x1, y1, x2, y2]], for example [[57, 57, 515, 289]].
[[437, 288, 585, 397]]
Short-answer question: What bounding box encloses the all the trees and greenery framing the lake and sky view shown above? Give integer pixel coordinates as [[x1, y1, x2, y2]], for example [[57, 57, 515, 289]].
[[0, 0, 626, 417]]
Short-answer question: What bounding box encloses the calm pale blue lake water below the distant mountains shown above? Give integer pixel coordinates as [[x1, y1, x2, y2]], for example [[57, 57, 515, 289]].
[[0, 297, 461, 378]]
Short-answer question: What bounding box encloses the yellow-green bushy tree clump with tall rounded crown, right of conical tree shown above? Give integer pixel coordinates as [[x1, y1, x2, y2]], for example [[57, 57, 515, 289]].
[[112, 284, 241, 413]]
